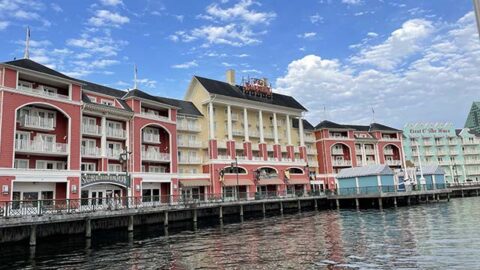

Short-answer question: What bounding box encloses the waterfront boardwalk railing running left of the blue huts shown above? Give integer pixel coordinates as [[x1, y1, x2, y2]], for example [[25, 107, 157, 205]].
[[0, 191, 325, 219]]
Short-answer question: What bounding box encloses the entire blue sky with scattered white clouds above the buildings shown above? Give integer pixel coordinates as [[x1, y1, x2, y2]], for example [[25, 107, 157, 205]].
[[0, 0, 480, 128]]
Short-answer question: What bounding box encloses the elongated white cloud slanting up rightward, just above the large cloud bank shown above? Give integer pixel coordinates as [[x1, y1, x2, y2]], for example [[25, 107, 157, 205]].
[[351, 19, 434, 70]]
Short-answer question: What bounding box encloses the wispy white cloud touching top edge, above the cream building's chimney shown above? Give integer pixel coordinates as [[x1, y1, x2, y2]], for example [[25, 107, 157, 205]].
[[206, 0, 276, 24]]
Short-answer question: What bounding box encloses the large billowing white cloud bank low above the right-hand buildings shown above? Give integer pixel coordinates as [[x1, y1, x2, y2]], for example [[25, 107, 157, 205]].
[[276, 12, 480, 128]]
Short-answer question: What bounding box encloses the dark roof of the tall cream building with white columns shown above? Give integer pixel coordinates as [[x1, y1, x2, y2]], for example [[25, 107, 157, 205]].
[[195, 76, 307, 111]]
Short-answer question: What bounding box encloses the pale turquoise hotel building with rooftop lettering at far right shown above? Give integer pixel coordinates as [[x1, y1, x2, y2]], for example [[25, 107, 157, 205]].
[[403, 123, 480, 184]]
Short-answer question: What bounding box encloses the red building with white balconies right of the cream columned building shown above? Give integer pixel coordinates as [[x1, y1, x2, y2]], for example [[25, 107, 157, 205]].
[[313, 120, 404, 189]]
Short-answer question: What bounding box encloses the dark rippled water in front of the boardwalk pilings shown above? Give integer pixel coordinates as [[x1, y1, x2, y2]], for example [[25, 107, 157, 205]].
[[0, 198, 480, 269]]
